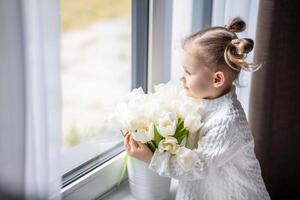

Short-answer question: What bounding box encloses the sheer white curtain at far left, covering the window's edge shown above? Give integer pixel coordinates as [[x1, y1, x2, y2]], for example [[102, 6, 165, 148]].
[[0, 0, 61, 199]]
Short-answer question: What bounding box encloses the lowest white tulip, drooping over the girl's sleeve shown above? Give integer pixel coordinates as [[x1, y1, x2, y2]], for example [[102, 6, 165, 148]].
[[176, 147, 198, 171]]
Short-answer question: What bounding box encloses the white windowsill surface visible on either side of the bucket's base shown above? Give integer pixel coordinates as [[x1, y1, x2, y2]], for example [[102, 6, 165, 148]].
[[99, 179, 178, 200]]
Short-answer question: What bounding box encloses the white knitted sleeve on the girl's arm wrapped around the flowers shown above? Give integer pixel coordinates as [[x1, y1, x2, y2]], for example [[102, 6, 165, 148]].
[[148, 115, 243, 181]]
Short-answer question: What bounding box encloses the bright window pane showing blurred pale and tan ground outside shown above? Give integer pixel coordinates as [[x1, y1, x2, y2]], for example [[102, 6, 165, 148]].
[[60, 0, 132, 178]]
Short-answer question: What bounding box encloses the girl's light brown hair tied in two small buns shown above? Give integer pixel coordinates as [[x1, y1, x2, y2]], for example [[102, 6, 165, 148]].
[[182, 17, 261, 76]]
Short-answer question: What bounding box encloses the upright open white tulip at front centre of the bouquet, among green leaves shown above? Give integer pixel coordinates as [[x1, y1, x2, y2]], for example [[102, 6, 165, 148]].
[[157, 112, 178, 137]]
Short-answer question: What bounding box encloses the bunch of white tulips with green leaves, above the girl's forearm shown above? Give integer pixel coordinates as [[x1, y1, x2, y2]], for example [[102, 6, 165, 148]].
[[111, 81, 203, 155]]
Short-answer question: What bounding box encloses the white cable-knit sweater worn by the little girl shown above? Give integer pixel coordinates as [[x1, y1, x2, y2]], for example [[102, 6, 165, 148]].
[[149, 85, 270, 200]]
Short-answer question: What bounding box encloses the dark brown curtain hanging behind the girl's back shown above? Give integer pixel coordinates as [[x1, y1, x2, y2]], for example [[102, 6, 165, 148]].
[[249, 0, 300, 199]]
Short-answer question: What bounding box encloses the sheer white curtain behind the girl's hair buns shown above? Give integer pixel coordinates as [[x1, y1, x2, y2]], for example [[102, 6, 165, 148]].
[[212, 0, 259, 117]]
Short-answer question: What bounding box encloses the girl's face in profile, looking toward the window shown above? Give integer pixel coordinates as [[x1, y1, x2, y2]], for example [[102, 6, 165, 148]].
[[180, 50, 214, 99]]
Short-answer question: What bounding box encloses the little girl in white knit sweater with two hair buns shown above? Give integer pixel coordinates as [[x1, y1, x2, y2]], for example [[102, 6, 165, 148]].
[[124, 17, 270, 200]]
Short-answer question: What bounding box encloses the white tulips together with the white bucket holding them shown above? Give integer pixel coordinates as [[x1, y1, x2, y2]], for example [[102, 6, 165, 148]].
[[109, 81, 203, 193]]
